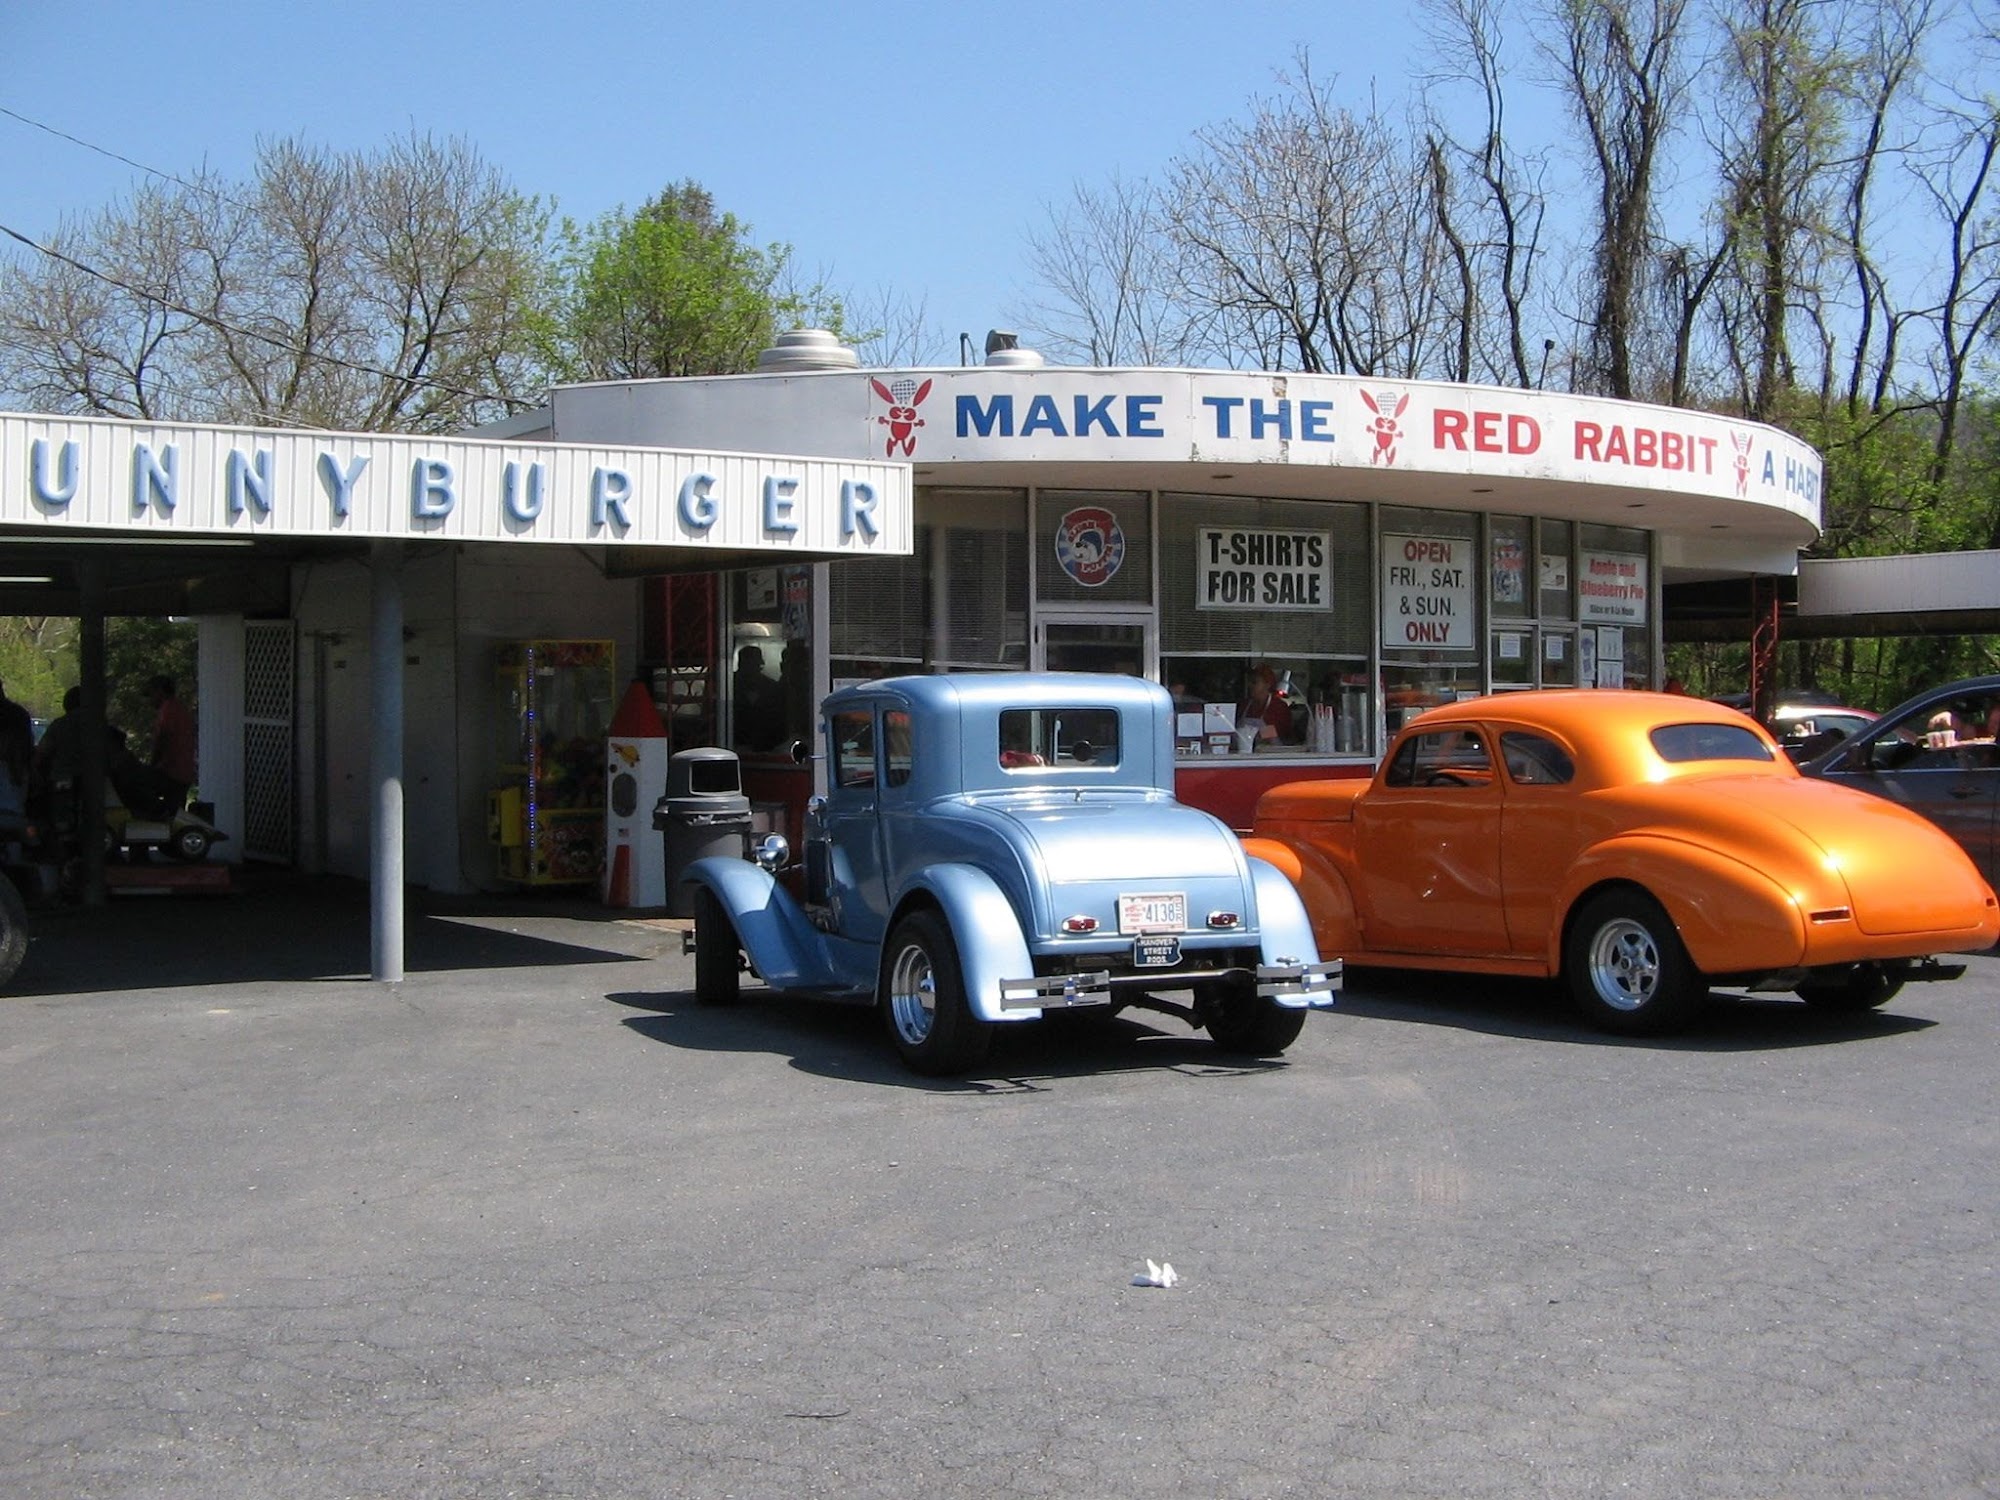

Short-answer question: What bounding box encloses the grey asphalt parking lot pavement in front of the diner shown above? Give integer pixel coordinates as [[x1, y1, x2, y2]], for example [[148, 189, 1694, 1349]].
[[0, 878, 2000, 1500]]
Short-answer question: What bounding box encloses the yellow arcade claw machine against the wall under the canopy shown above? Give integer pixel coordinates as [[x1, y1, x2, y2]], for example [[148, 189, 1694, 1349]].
[[486, 640, 616, 886]]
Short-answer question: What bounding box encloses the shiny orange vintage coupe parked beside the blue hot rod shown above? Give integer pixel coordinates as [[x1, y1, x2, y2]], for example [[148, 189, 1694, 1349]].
[[1244, 690, 2000, 1032]]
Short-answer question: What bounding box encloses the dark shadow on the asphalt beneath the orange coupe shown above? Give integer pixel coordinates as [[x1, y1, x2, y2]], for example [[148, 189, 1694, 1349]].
[[1336, 966, 1936, 1052]]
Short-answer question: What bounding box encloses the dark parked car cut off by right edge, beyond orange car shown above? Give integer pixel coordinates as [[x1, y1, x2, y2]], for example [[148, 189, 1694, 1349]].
[[1800, 676, 2000, 886]]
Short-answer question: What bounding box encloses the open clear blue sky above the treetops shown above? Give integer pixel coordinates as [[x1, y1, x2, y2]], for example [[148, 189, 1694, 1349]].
[[0, 0, 1418, 358]]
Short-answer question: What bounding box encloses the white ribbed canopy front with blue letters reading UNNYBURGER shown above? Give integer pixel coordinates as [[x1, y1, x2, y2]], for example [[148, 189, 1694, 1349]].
[[0, 414, 912, 556]]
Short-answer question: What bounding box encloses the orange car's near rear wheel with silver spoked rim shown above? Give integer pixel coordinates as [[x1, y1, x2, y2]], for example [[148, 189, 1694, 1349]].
[[1562, 890, 1708, 1036]]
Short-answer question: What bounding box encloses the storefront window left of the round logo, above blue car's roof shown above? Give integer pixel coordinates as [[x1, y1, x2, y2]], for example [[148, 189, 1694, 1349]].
[[828, 490, 1028, 682]]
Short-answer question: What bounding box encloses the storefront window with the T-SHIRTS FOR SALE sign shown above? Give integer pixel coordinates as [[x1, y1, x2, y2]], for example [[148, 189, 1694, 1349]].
[[1160, 494, 1372, 754]]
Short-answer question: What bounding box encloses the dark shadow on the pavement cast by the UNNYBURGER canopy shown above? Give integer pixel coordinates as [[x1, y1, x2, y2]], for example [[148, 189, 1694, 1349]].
[[6, 870, 656, 998]]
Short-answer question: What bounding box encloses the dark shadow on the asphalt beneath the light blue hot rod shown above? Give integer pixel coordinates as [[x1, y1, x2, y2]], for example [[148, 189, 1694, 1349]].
[[606, 984, 1288, 1094]]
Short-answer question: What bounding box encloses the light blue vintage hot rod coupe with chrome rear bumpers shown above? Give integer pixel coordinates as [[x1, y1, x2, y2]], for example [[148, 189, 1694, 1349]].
[[682, 672, 1340, 1074]]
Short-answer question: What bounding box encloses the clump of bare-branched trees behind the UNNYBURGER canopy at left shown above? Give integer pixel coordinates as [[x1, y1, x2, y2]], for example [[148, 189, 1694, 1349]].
[[0, 136, 544, 432]]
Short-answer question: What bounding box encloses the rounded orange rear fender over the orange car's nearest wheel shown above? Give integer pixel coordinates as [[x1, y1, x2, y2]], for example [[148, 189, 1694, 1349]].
[[1548, 834, 1806, 974]]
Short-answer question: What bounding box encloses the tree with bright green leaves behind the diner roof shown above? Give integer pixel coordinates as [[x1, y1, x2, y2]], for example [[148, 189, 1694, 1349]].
[[542, 180, 846, 380]]
